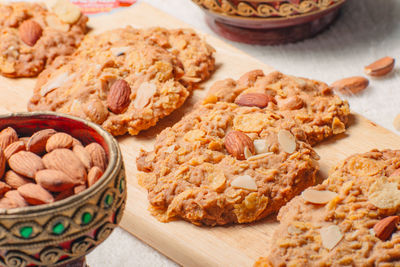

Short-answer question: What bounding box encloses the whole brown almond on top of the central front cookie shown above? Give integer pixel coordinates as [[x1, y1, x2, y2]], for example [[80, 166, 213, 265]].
[[225, 131, 255, 160]]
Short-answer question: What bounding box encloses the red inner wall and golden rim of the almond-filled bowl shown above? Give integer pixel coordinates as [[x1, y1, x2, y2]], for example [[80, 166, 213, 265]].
[[0, 112, 120, 218]]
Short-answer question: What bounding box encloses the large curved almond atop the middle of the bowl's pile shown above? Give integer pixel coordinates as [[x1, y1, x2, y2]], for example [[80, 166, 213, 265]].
[[43, 148, 87, 183]]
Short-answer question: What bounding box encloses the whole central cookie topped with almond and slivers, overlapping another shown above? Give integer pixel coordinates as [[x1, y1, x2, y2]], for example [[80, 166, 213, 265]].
[[137, 102, 318, 225]]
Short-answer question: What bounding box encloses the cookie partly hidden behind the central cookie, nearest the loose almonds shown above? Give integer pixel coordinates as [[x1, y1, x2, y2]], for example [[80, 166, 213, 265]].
[[206, 70, 350, 145]]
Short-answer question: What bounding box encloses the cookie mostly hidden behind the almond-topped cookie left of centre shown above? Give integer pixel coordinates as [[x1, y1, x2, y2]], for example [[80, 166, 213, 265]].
[[77, 26, 215, 85]]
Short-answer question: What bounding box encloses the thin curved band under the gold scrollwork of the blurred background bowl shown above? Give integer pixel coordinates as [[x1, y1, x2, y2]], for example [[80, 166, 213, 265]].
[[192, 0, 346, 22]]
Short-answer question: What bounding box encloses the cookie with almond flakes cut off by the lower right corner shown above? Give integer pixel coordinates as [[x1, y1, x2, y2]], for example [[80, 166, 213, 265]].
[[255, 150, 400, 266]]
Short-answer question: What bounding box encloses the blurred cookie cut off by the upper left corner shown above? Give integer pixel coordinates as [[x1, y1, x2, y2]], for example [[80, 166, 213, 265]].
[[0, 0, 88, 78]]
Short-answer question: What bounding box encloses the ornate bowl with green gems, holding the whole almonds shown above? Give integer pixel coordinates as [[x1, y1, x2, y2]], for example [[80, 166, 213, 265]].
[[0, 112, 126, 267]]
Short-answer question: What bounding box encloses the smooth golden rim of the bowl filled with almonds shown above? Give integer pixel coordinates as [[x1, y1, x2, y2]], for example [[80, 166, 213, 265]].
[[0, 111, 122, 219]]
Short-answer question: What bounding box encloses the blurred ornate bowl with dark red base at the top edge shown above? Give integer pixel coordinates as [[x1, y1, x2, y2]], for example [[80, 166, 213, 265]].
[[192, 0, 346, 45]]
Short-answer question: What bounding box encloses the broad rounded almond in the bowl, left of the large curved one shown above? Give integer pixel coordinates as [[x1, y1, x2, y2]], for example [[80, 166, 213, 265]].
[[8, 151, 44, 178]]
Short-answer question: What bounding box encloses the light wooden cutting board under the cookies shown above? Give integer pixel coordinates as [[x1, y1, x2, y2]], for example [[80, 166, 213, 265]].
[[0, 4, 400, 266]]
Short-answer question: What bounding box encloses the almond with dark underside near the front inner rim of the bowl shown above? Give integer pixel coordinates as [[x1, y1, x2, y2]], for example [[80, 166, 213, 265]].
[[17, 183, 54, 205]]
